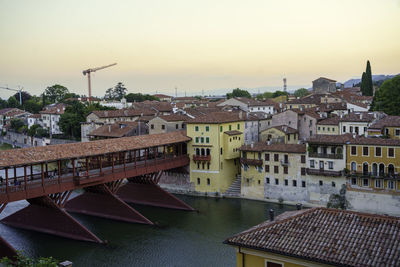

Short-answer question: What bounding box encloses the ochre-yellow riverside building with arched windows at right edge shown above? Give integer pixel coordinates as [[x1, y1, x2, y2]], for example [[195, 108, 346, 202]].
[[346, 137, 400, 193]]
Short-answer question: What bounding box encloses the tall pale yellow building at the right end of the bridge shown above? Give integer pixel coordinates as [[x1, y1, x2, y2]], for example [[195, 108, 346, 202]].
[[187, 112, 244, 193]]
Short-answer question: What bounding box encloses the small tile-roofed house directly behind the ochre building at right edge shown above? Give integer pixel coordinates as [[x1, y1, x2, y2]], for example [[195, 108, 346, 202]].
[[368, 116, 400, 139]]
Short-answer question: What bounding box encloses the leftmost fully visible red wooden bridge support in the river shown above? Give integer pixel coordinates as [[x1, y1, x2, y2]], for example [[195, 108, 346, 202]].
[[2, 194, 102, 243]]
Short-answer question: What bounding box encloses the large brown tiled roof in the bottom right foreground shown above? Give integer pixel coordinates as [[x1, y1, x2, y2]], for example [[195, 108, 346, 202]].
[[224, 208, 400, 267]]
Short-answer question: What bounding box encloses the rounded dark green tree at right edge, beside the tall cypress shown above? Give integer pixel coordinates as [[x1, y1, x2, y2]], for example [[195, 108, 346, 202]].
[[372, 75, 400, 116]]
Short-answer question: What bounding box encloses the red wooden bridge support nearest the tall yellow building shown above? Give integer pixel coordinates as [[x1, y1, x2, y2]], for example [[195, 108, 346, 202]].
[[117, 171, 194, 211]]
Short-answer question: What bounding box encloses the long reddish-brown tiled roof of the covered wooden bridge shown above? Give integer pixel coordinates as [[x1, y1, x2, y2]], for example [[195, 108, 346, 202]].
[[0, 131, 191, 168]]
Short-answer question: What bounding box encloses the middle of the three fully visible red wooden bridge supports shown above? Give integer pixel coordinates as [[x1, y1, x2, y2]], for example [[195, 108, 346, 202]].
[[65, 183, 153, 224]]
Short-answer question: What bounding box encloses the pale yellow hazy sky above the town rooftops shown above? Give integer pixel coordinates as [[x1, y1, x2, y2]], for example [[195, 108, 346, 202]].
[[0, 0, 400, 98]]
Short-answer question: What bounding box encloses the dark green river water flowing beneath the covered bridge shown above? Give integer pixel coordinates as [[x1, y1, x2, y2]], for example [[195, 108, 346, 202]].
[[0, 195, 295, 266]]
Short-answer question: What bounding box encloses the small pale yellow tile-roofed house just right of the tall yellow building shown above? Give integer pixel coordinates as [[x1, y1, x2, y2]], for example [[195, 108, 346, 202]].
[[260, 125, 299, 144]]
